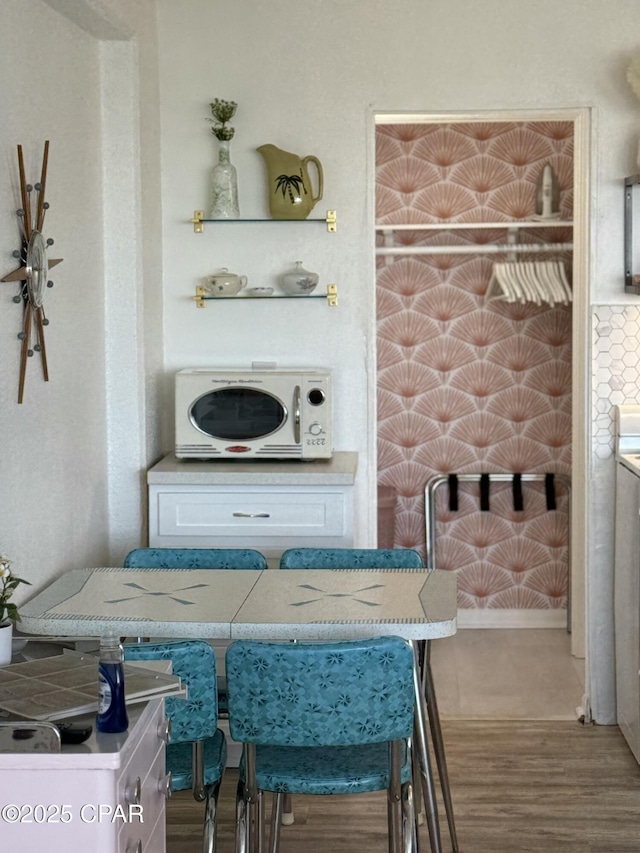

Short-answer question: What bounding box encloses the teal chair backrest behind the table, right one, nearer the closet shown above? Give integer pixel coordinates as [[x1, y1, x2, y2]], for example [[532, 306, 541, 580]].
[[280, 548, 424, 569]]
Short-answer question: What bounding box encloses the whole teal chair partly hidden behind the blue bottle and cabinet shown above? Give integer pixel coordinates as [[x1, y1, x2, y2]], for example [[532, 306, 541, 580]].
[[124, 640, 227, 853]]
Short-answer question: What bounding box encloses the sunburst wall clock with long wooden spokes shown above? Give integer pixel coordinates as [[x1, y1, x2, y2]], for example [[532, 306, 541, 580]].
[[0, 140, 62, 403]]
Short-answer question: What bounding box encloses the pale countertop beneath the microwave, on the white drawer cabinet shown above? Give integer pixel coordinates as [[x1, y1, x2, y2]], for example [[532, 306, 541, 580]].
[[147, 451, 358, 486]]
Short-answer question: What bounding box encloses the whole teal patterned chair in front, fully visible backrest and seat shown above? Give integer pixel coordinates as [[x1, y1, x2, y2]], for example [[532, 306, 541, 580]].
[[226, 637, 416, 853]]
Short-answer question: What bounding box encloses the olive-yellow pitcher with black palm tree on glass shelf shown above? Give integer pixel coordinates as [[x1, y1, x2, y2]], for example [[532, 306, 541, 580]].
[[257, 145, 323, 219]]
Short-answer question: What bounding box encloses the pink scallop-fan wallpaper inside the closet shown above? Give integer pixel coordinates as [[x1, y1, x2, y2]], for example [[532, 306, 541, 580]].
[[376, 122, 573, 609]]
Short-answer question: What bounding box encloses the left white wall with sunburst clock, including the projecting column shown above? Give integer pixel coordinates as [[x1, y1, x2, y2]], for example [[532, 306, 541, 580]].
[[0, 0, 162, 602]]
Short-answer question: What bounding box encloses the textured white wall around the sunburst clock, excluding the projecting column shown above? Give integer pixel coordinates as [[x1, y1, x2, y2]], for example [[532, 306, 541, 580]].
[[0, 0, 108, 597]]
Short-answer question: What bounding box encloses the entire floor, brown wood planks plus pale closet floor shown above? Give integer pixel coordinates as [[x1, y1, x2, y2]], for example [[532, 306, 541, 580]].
[[167, 629, 640, 853]]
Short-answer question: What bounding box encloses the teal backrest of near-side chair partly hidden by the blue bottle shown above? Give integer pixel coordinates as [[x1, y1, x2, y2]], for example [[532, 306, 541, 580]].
[[124, 640, 218, 743]]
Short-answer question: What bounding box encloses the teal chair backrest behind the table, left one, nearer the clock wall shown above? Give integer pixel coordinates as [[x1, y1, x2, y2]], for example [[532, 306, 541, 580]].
[[124, 548, 267, 569]]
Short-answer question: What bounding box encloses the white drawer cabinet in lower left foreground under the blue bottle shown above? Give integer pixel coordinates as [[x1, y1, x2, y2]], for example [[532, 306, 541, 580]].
[[0, 699, 166, 853]]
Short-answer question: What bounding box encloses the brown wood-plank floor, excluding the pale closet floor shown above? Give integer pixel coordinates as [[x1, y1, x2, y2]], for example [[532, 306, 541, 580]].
[[167, 720, 640, 853]]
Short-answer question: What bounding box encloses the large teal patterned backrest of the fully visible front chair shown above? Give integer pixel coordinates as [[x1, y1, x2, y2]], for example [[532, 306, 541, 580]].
[[226, 637, 415, 746]]
